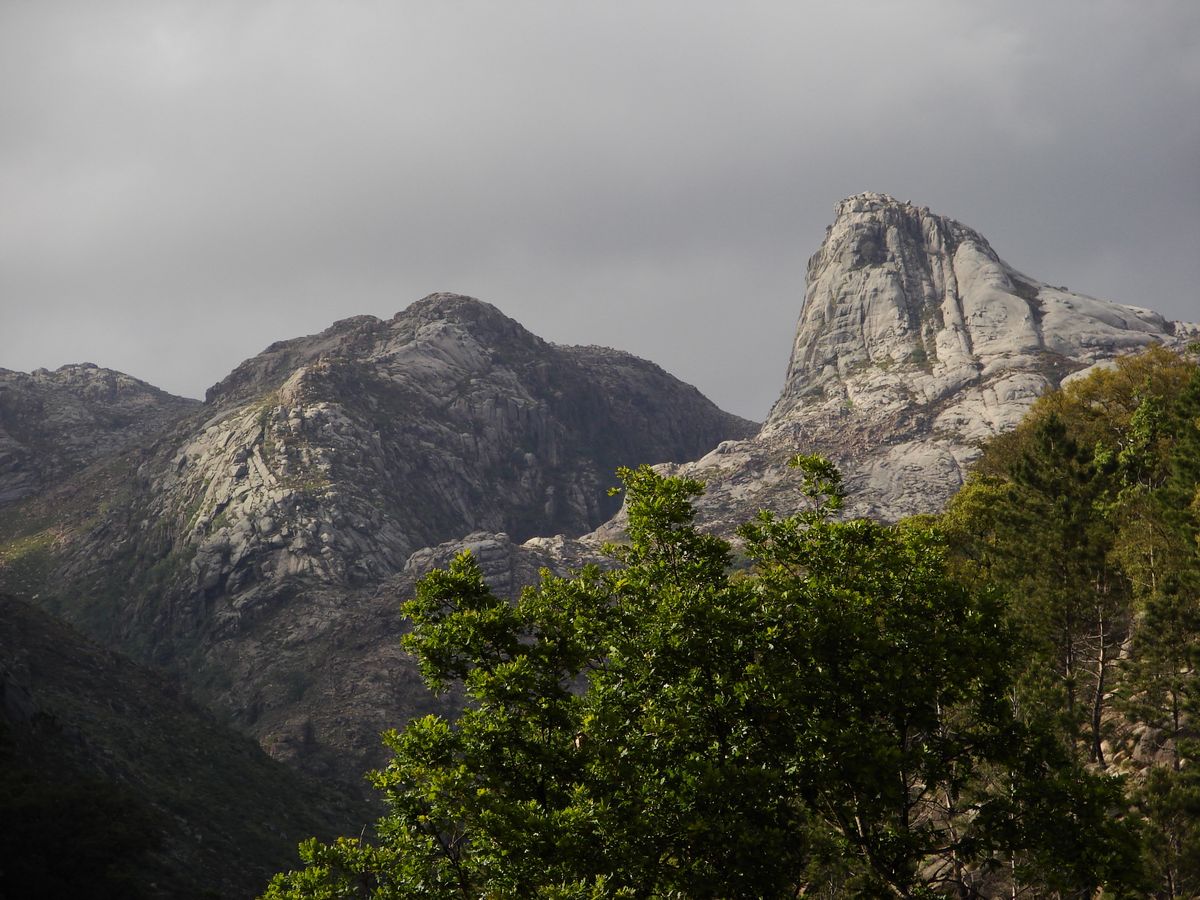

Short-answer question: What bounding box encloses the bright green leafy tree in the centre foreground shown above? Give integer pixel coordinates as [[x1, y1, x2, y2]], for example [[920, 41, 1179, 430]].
[[268, 457, 1138, 898]]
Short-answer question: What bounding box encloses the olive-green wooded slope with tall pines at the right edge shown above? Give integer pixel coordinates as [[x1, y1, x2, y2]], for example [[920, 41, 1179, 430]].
[[946, 349, 1200, 898]]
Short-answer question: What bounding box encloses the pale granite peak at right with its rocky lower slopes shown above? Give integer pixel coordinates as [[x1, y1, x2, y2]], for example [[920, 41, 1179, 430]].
[[604, 193, 1198, 528]]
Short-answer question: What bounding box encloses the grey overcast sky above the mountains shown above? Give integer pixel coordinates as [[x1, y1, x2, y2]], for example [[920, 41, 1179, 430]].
[[0, 0, 1200, 418]]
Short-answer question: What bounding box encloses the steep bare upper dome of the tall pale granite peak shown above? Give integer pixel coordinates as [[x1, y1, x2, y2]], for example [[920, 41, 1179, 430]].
[[766, 193, 1171, 438]]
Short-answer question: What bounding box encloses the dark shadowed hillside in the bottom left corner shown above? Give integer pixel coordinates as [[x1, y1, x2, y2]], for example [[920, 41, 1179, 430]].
[[0, 595, 367, 898]]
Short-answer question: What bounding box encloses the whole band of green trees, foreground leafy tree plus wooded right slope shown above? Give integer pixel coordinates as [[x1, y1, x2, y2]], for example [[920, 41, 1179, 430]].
[[268, 350, 1200, 898]]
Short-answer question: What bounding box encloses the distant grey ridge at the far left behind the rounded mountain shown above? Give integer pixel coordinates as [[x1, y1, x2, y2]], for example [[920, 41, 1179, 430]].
[[0, 362, 199, 505]]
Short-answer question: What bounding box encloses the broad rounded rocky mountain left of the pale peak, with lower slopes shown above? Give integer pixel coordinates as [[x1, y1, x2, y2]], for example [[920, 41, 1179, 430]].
[[0, 294, 756, 786]]
